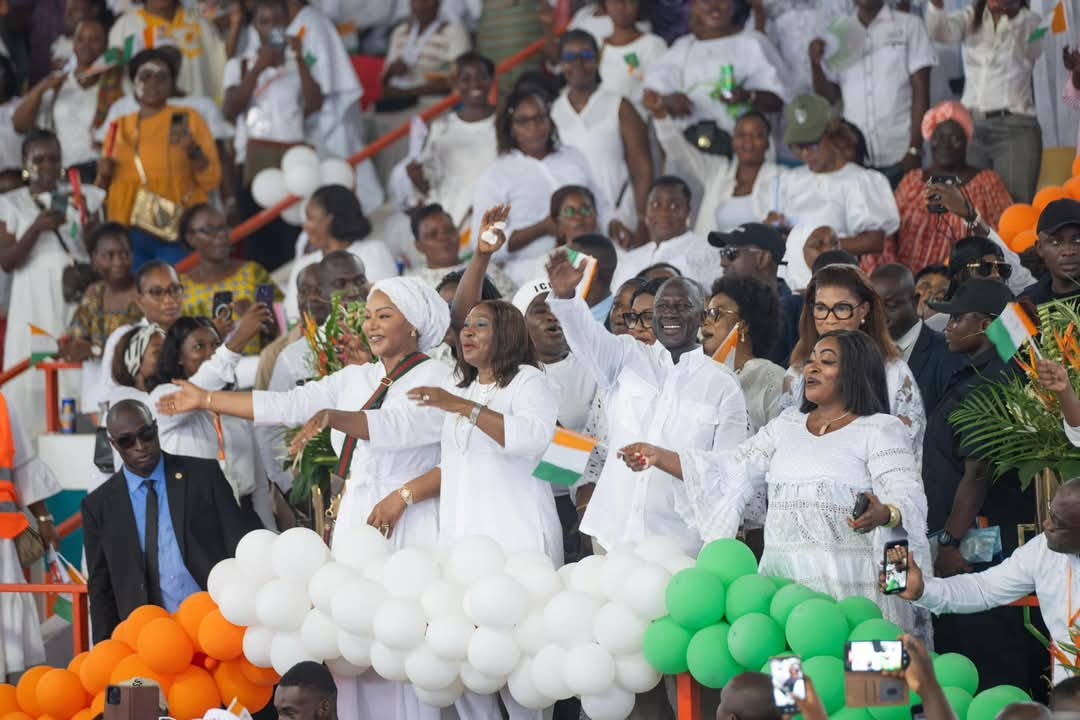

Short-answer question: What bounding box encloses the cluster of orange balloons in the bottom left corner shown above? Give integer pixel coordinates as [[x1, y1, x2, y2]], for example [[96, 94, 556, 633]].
[[0, 593, 280, 720]]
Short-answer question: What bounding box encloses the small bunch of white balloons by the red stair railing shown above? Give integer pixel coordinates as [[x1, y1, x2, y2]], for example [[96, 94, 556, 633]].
[[252, 145, 356, 225]]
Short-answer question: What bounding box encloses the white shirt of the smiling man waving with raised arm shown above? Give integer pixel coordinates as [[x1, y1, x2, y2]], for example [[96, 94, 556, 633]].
[[548, 298, 747, 556]]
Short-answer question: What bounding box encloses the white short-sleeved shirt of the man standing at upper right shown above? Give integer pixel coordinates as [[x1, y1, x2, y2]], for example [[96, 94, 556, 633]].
[[826, 5, 937, 167]]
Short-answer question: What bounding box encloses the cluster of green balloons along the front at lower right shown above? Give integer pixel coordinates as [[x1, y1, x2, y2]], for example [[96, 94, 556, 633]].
[[643, 540, 1030, 720]]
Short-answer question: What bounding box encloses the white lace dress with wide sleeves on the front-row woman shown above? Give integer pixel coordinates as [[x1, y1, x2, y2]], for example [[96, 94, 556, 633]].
[[675, 408, 933, 639]]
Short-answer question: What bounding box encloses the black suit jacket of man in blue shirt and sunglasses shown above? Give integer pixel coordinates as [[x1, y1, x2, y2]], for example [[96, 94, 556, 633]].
[[82, 452, 254, 642]]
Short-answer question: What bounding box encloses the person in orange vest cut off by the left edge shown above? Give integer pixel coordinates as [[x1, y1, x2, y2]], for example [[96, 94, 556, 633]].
[[0, 394, 60, 679]]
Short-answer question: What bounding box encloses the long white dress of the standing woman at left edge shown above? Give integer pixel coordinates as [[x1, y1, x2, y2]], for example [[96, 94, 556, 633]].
[[0, 185, 105, 437]]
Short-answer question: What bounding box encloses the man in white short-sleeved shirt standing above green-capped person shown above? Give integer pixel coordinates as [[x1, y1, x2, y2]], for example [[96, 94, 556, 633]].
[[810, 0, 937, 189]]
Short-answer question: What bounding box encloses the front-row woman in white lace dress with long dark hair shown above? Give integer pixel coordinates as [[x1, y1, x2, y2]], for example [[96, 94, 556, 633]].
[[622, 330, 930, 637]]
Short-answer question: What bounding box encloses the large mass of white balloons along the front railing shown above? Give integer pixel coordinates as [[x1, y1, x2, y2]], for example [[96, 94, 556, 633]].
[[207, 526, 693, 720]]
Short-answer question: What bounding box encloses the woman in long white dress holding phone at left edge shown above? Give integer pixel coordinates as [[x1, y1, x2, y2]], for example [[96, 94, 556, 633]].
[[0, 131, 105, 437]]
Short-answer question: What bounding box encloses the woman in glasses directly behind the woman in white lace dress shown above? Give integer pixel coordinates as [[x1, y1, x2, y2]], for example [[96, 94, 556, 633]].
[[780, 264, 927, 467]]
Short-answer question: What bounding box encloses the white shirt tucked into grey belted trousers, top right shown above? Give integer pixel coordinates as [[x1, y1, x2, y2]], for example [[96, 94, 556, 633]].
[[927, 2, 1045, 116]]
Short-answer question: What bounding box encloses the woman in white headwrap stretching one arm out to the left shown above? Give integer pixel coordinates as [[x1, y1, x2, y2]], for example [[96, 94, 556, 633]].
[[159, 277, 453, 720]]
